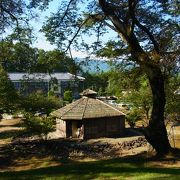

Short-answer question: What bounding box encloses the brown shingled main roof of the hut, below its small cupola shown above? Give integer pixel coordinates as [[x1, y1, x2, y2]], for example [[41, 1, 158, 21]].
[[51, 96, 124, 120]]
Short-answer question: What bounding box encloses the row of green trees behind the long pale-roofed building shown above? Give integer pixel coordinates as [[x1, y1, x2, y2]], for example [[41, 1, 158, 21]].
[[0, 40, 80, 74]]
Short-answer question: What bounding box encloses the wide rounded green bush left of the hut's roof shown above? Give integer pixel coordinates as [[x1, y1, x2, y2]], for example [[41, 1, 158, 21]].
[[21, 93, 63, 114]]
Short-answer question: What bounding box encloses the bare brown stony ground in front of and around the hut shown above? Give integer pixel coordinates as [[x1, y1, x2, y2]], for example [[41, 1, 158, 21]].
[[0, 119, 180, 171]]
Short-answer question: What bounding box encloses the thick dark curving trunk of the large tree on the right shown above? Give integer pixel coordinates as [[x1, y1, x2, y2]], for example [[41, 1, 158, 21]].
[[128, 33, 171, 156]]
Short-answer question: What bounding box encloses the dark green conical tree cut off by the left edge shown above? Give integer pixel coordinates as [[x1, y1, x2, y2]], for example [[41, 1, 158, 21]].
[[0, 65, 18, 111]]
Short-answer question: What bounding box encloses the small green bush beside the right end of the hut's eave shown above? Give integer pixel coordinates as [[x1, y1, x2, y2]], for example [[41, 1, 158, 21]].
[[126, 108, 142, 128]]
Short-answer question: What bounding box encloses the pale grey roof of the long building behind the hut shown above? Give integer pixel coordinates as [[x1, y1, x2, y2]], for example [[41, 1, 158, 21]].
[[8, 73, 85, 81]]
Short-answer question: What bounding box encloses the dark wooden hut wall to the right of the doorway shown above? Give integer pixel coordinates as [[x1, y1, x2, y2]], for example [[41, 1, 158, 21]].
[[84, 115, 125, 139]]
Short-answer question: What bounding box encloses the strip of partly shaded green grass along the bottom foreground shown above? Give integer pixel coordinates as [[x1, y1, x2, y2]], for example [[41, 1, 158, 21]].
[[0, 159, 180, 180]]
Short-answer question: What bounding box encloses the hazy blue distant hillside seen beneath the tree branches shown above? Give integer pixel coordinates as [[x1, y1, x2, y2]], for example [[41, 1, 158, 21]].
[[76, 58, 110, 72]]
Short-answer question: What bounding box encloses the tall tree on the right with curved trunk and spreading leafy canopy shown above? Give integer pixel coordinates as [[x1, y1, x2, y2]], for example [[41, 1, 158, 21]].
[[43, 0, 179, 155]]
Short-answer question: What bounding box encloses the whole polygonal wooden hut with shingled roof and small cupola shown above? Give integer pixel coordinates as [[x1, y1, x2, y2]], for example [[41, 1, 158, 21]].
[[51, 89, 125, 139]]
